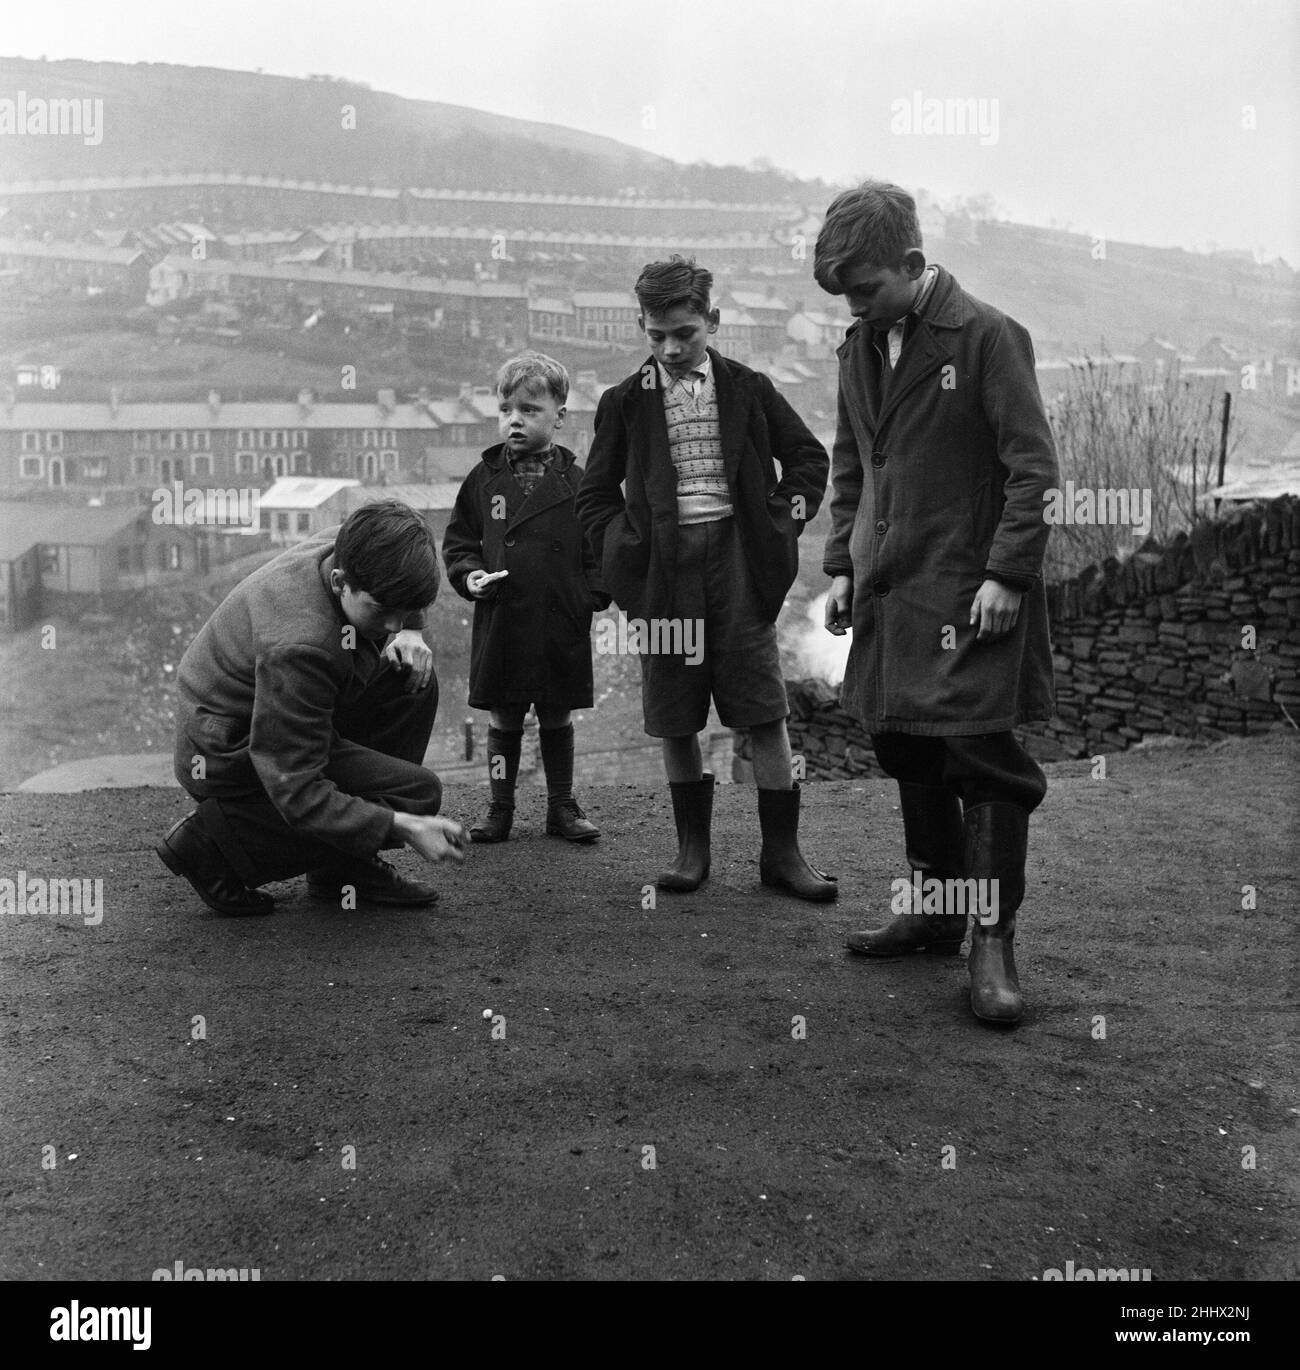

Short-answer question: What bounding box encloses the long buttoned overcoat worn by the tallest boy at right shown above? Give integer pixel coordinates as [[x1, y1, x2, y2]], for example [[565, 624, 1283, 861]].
[[823, 267, 1058, 737]]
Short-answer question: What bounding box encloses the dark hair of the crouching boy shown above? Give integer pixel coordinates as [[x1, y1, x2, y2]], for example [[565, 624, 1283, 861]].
[[334, 500, 441, 610]]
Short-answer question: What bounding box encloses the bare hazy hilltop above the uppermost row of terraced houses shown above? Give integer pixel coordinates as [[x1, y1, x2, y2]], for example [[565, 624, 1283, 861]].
[[0, 58, 825, 201]]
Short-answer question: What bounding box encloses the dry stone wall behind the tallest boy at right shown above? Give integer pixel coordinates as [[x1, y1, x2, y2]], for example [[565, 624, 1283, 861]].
[[788, 496, 1300, 780]]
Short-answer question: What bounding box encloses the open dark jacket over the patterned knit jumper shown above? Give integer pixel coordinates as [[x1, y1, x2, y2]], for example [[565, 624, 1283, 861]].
[[578, 348, 830, 623]]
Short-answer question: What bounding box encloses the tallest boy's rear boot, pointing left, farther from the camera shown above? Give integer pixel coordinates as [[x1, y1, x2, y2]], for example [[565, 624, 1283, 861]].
[[845, 782, 966, 956]]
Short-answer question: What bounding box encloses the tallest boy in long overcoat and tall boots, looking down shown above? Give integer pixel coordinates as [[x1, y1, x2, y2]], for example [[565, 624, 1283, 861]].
[[814, 181, 1058, 1022]]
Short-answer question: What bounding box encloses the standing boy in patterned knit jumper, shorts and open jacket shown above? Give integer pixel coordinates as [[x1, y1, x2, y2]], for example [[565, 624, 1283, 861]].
[[578, 256, 837, 900]]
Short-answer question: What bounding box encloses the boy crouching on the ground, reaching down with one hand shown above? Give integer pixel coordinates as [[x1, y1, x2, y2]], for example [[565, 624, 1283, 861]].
[[156, 500, 467, 914]]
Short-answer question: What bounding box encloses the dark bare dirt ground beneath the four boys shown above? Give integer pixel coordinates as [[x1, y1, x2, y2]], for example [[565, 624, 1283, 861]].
[[0, 734, 1300, 1281]]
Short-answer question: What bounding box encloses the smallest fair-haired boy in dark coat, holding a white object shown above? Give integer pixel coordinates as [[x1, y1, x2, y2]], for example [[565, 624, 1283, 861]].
[[442, 352, 610, 843]]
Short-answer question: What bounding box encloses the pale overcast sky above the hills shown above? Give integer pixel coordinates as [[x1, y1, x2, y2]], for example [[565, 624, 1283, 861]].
[[0, 0, 1300, 264]]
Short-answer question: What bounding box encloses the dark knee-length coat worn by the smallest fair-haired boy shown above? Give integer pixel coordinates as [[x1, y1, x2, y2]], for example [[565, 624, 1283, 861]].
[[442, 443, 610, 710]]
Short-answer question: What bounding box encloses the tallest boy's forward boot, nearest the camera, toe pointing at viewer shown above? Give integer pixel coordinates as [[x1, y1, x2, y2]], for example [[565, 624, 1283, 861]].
[[966, 803, 1029, 1023]]
